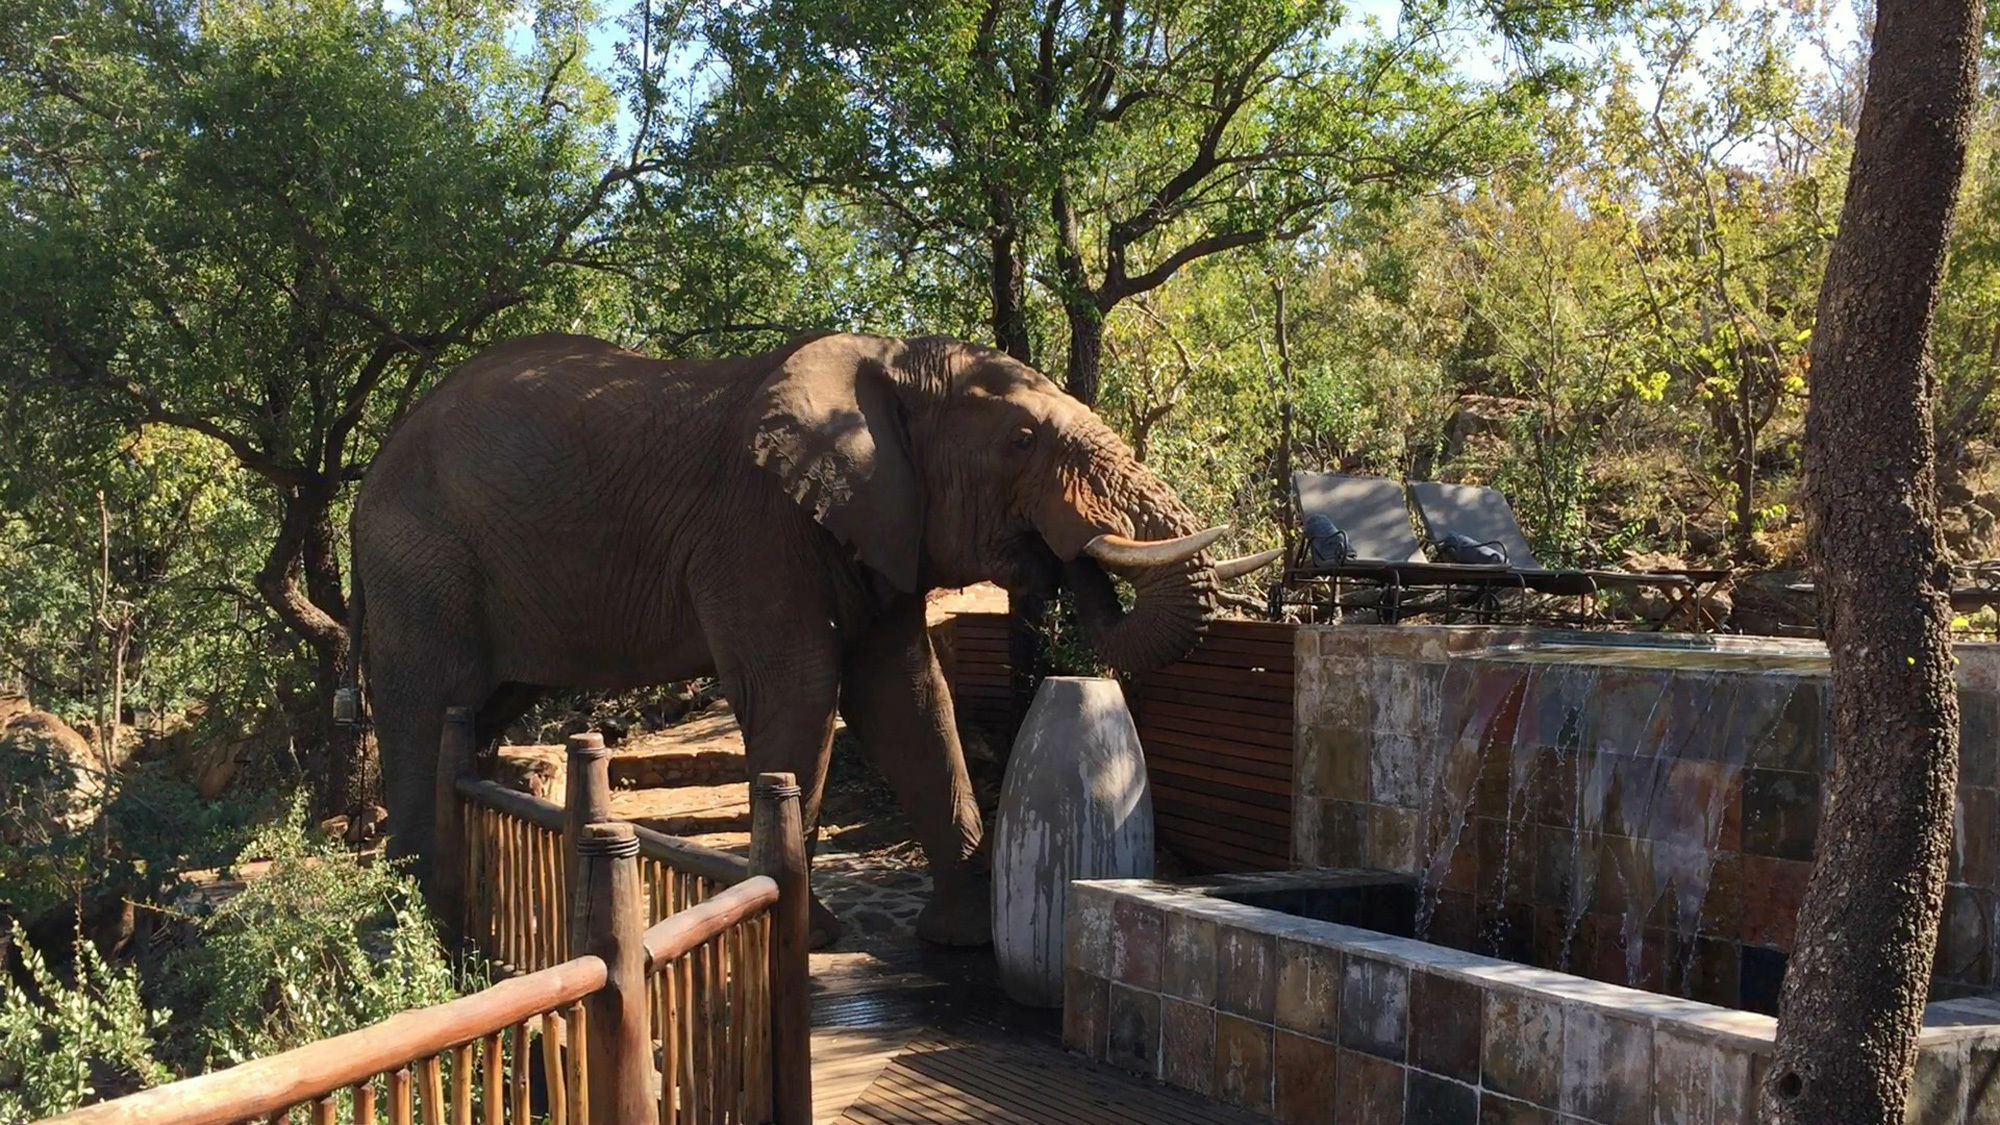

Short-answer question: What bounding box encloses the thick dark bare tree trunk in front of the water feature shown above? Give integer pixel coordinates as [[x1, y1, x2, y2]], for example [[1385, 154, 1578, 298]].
[[1762, 0, 1980, 1125]]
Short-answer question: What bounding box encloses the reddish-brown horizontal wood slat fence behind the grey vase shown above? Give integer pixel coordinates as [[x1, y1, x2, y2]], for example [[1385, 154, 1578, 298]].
[[936, 613, 1296, 871]]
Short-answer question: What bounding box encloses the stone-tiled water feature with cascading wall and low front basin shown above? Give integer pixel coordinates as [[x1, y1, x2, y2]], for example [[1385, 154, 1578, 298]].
[[1064, 627, 2000, 1125]]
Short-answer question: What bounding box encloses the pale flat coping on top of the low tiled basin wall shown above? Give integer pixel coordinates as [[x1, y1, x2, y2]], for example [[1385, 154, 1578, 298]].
[[1070, 875, 2000, 1053]]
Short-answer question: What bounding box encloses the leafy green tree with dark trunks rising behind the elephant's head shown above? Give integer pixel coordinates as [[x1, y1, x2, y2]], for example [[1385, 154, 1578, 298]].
[[698, 0, 1586, 404]]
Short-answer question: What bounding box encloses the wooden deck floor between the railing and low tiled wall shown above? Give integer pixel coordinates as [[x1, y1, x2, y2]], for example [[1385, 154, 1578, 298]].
[[812, 951, 1262, 1125]]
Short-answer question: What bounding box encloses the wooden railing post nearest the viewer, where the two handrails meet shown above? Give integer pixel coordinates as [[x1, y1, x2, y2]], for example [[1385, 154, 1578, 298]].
[[570, 821, 654, 1125]]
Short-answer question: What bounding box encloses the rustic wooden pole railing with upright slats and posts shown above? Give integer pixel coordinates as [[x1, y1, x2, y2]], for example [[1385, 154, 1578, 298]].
[[44, 709, 812, 1125]]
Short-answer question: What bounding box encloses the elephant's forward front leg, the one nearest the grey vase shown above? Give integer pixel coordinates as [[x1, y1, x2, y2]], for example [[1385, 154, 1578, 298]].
[[840, 595, 992, 945]]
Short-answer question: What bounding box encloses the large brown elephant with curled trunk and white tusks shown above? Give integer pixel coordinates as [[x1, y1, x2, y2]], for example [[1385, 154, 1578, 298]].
[[350, 332, 1274, 945]]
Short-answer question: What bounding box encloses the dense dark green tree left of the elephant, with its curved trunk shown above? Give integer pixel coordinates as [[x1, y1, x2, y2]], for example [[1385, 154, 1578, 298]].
[[0, 0, 658, 809]]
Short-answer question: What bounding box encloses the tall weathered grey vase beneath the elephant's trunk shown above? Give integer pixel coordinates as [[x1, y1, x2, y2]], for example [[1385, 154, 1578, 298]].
[[992, 677, 1152, 1007]]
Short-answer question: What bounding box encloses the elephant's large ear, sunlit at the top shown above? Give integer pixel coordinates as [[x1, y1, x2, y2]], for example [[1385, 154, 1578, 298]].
[[750, 336, 924, 591]]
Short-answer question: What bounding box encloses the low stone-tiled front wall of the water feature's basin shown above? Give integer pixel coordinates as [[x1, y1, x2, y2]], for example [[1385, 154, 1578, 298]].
[[1062, 881, 2000, 1125]]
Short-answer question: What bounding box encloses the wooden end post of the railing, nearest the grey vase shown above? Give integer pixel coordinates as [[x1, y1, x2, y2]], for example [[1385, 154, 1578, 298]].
[[750, 773, 812, 1125]]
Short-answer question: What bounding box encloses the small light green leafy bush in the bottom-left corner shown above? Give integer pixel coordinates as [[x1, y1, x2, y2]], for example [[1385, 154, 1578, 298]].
[[0, 923, 172, 1121]]
